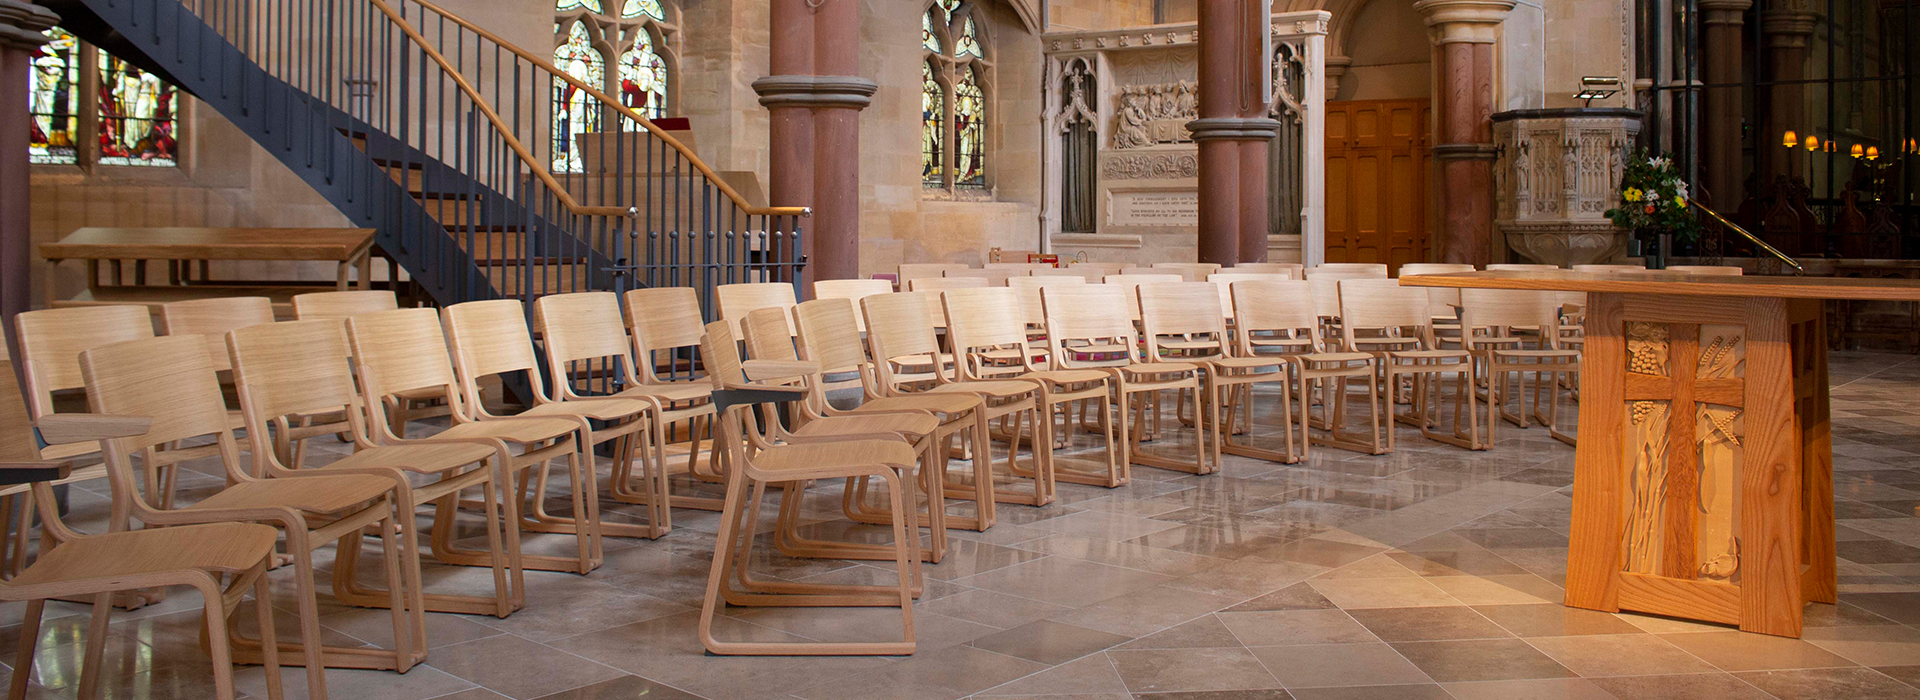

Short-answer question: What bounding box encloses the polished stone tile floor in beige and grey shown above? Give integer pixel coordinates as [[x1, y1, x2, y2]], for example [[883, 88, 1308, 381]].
[[11, 353, 1920, 700]]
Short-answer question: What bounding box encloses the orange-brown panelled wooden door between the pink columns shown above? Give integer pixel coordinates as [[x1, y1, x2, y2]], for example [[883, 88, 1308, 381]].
[[1327, 100, 1428, 270]]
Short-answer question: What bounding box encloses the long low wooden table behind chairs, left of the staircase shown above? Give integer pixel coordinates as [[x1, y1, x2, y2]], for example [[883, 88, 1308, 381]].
[[40, 228, 374, 314]]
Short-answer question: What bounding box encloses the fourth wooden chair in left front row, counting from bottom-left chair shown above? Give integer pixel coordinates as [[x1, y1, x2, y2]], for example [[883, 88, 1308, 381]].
[[348, 309, 586, 586]]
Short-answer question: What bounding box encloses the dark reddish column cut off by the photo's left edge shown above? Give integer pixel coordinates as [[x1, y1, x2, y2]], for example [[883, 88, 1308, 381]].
[[0, 0, 60, 372]]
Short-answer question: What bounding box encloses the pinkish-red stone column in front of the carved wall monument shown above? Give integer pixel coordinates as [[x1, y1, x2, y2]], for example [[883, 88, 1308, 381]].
[[1187, 0, 1281, 265]]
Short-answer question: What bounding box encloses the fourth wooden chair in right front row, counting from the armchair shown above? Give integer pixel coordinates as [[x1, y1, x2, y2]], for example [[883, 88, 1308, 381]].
[[860, 293, 1054, 506]]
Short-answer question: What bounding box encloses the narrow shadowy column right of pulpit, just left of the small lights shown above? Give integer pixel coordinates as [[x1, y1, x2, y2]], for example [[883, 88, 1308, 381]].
[[1695, 0, 1751, 211]]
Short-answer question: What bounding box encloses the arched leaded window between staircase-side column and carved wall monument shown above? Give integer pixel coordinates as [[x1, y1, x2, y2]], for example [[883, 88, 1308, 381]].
[[920, 0, 993, 190]]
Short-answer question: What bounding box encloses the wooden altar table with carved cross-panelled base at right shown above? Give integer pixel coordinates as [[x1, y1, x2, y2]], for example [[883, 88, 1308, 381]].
[[1400, 272, 1920, 637]]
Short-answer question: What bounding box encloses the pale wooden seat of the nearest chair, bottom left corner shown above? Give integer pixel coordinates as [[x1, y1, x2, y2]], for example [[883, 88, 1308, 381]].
[[8, 522, 280, 587]]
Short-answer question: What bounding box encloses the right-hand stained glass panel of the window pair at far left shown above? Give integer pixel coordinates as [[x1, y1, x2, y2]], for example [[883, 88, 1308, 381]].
[[100, 52, 179, 167]]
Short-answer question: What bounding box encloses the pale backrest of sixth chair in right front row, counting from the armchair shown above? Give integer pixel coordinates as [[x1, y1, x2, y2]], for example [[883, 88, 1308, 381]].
[[1041, 284, 1140, 368]]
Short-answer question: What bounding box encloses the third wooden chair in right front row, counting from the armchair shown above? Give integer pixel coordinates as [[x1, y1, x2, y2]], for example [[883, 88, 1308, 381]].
[[793, 299, 995, 533]]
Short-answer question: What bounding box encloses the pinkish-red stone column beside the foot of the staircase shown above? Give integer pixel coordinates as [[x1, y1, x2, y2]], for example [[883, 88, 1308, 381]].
[[753, 0, 877, 288]]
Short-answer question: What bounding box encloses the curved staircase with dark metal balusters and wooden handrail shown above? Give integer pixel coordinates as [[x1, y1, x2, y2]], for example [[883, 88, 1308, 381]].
[[40, 0, 806, 308]]
